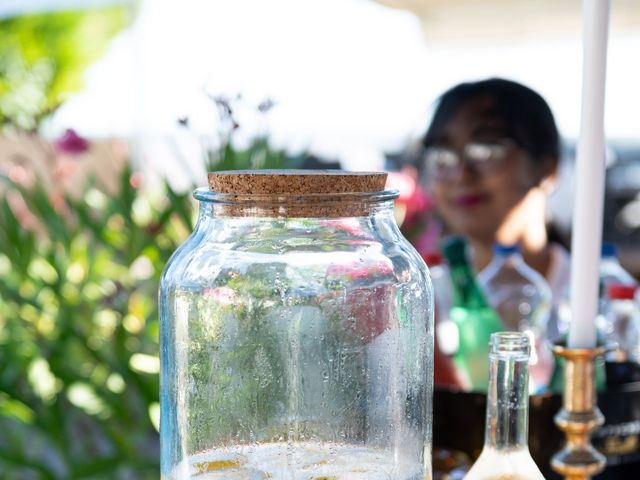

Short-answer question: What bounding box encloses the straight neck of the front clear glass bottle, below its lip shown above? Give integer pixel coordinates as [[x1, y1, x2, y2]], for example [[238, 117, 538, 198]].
[[485, 346, 529, 450]]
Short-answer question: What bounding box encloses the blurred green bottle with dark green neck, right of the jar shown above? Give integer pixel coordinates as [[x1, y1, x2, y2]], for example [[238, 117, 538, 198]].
[[442, 236, 505, 392]]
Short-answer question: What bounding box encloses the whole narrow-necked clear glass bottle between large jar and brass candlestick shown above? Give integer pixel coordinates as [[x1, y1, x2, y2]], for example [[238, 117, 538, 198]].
[[465, 332, 544, 480]]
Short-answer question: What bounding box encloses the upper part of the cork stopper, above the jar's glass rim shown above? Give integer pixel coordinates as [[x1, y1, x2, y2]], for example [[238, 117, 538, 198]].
[[209, 170, 387, 195]]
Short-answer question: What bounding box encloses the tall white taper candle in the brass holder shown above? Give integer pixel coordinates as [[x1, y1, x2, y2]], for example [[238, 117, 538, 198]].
[[569, 0, 610, 348]]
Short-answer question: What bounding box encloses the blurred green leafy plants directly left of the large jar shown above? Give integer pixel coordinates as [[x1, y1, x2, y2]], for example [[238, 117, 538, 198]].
[[0, 170, 193, 480]]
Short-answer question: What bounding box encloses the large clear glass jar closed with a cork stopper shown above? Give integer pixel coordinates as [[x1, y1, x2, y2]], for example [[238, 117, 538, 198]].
[[160, 171, 433, 480]]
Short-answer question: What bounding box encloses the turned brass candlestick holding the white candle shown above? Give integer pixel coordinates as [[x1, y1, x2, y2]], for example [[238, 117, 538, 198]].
[[551, 345, 606, 480]]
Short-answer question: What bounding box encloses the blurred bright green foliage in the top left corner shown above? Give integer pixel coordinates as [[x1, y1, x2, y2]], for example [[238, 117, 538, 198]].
[[0, 6, 127, 130]]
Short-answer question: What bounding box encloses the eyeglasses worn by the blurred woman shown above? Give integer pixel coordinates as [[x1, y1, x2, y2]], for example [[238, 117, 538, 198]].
[[423, 138, 516, 180]]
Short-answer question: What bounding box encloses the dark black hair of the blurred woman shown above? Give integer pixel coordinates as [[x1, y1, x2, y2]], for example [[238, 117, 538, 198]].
[[423, 78, 560, 160]]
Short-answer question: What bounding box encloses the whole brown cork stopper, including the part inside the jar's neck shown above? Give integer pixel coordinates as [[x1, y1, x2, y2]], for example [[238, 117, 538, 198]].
[[209, 170, 395, 218]]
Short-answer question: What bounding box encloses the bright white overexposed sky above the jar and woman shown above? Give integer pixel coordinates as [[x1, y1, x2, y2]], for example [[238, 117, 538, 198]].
[[51, 0, 640, 178]]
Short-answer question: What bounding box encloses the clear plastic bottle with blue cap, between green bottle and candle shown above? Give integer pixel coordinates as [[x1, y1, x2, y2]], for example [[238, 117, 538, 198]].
[[478, 244, 553, 392]]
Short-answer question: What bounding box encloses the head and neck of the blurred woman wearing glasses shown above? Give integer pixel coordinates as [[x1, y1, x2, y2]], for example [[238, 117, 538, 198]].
[[422, 78, 569, 293]]
